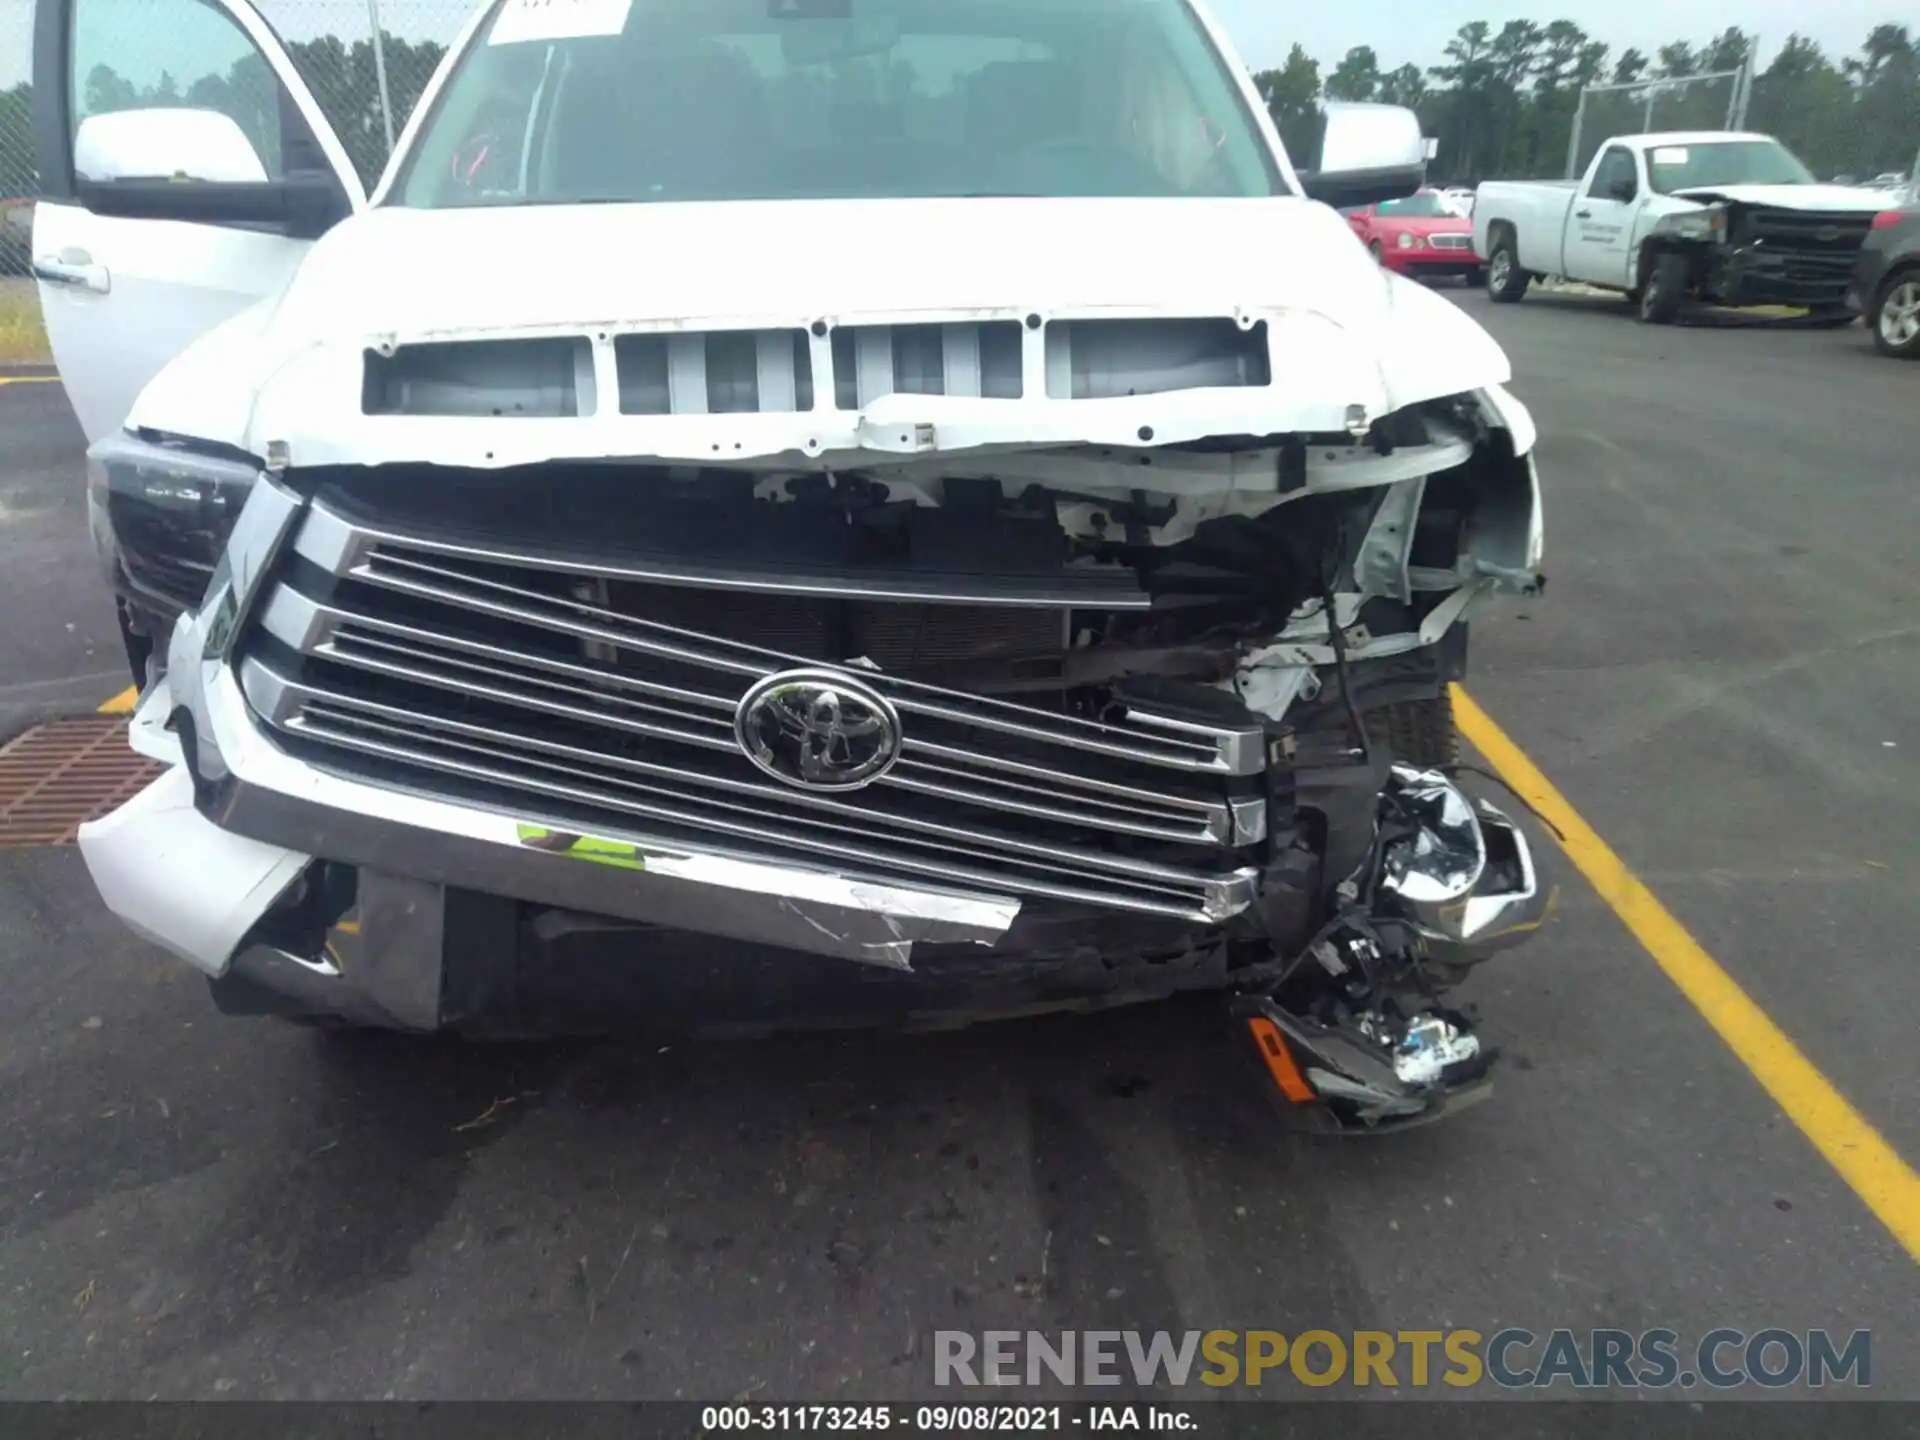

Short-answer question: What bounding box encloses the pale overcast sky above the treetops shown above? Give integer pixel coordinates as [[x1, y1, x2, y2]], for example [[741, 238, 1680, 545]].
[[0, 0, 1914, 84]]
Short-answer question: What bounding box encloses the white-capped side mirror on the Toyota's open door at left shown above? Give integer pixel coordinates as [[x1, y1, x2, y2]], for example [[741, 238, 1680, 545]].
[[73, 108, 353, 240]]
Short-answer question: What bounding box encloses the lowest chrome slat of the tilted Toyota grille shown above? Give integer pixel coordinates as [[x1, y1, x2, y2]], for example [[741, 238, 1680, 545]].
[[270, 695, 1250, 920]]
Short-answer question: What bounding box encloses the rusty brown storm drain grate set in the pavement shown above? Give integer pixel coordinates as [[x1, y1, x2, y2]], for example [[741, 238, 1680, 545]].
[[0, 714, 165, 847]]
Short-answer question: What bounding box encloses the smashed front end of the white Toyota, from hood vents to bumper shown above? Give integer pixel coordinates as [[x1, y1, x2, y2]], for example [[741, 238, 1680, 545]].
[[83, 315, 1546, 1129]]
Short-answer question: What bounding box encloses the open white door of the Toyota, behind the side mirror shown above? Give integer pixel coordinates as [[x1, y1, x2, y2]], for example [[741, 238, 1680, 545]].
[[33, 0, 367, 442]]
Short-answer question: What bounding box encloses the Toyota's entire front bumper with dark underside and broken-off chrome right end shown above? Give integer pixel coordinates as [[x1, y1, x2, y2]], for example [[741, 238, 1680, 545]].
[[81, 680, 1553, 1036]]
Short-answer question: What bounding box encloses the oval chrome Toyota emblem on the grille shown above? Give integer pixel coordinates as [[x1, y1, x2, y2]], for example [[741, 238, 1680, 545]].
[[733, 670, 900, 789]]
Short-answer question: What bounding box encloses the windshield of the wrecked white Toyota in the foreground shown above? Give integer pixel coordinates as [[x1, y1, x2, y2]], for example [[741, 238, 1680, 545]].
[[394, 0, 1284, 209]]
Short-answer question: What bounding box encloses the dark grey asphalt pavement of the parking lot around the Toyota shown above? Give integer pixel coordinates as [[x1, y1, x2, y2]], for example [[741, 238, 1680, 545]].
[[0, 294, 1920, 1400]]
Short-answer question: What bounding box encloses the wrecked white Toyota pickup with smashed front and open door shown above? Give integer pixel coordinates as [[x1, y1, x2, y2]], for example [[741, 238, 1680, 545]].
[[33, 0, 1549, 1129]]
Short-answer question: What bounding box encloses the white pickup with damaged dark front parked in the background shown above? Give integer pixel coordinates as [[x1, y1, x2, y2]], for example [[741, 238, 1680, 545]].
[[1473, 131, 1884, 324]]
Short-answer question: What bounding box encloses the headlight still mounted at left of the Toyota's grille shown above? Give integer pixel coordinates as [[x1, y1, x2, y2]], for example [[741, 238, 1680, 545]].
[[86, 432, 259, 616]]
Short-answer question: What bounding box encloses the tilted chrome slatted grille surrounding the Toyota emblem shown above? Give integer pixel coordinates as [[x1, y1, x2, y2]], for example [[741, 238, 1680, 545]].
[[242, 503, 1267, 920]]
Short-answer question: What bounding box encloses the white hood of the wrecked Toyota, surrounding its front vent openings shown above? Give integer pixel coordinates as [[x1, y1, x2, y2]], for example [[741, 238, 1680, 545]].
[[129, 202, 1511, 468]]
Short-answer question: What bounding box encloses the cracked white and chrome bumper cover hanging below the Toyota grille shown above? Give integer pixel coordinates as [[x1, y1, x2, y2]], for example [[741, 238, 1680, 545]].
[[81, 668, 1020, 975]]
